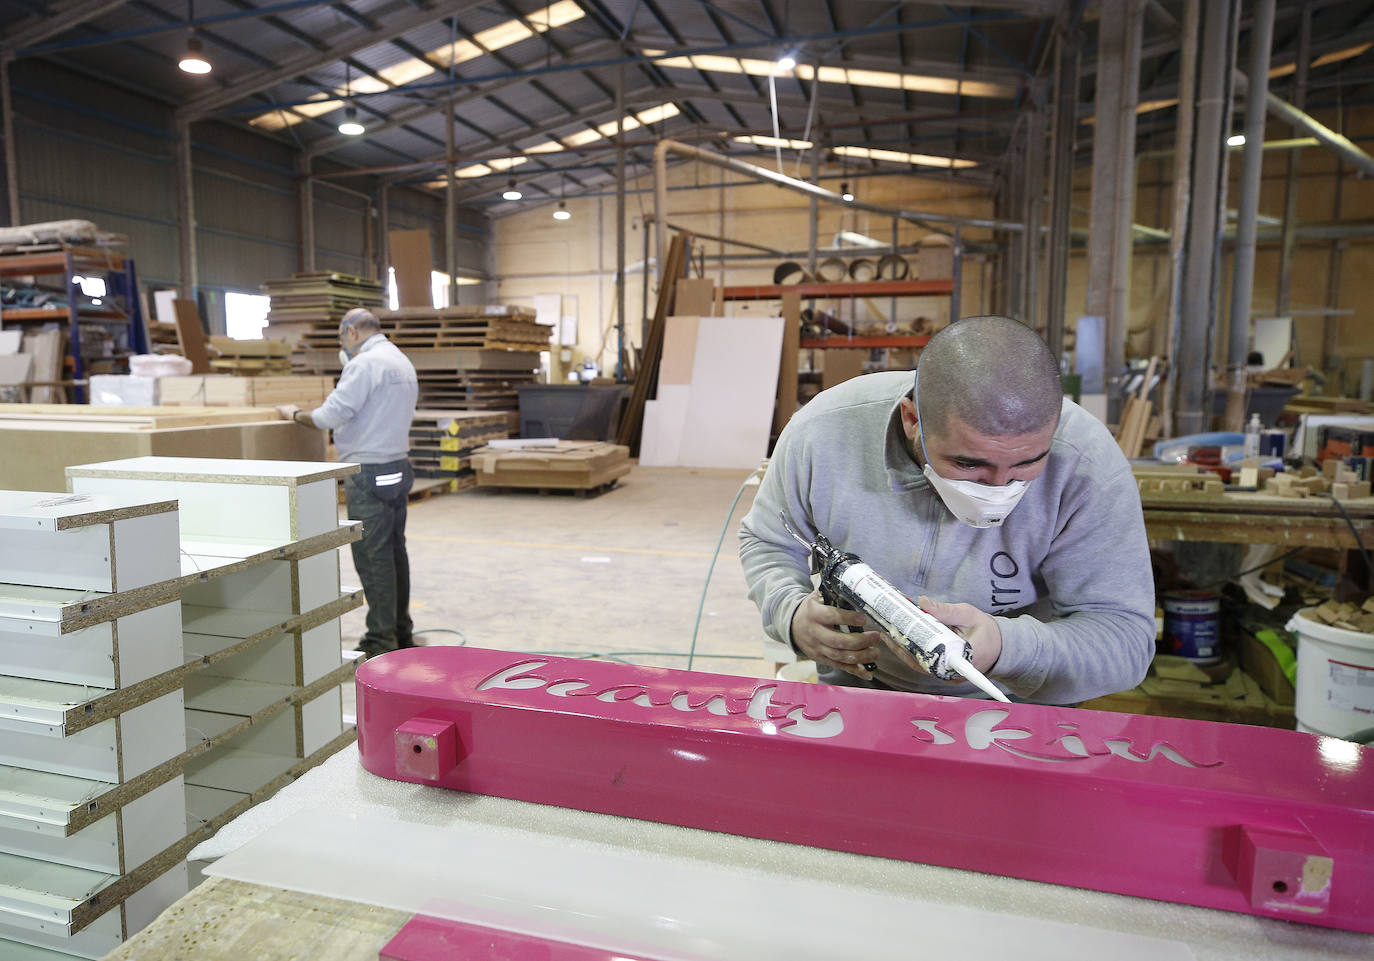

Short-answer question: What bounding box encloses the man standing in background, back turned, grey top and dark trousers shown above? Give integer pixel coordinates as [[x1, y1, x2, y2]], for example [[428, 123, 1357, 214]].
[[276, 307, 418, 657]]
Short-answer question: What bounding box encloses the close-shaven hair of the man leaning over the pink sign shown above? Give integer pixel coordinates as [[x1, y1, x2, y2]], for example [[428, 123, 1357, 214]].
[[915, 313, 1063, 437]]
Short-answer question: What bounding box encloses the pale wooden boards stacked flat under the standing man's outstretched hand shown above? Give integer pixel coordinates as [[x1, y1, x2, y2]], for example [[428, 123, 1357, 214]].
[[0, 404, 324, 491]]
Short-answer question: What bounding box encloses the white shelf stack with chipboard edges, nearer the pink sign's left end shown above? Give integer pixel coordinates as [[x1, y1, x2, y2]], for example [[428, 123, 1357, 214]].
[[67, 456, 363, 874]]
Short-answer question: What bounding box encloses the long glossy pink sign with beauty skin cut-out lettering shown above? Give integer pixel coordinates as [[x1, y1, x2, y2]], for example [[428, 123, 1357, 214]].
[[357, 648, 1374, 932]]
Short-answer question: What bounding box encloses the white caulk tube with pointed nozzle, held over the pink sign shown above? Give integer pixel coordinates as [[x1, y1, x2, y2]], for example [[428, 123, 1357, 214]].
[[833, 554, 1009, 701]]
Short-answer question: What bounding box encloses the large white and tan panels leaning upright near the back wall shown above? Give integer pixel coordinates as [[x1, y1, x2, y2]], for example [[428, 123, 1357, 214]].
[[639, 316, 783, 469]]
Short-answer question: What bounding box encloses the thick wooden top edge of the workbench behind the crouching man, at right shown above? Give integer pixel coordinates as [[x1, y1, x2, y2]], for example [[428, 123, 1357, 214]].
[[1140, 491, 1374, 550]]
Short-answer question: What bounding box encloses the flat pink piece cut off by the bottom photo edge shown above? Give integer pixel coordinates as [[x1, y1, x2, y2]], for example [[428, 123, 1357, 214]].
[[376, 914, 665, 961]]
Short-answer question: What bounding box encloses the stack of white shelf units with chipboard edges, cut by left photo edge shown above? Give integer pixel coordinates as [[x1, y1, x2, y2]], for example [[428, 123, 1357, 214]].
[[0, 491, 187, 958]]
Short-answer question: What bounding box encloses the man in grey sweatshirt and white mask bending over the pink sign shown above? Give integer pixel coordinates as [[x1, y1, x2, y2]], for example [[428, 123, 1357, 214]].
[[739, 316, 1154, 704]]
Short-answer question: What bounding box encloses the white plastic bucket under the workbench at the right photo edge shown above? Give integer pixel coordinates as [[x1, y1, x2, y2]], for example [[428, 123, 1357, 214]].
[[1286, 608, 1374, 737]]
